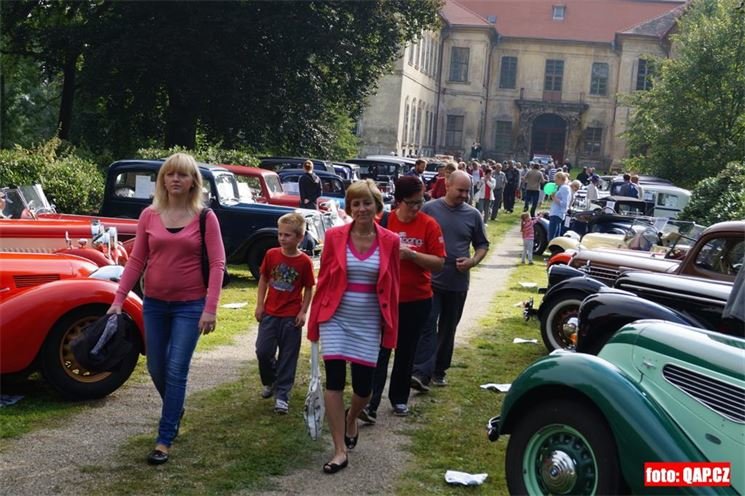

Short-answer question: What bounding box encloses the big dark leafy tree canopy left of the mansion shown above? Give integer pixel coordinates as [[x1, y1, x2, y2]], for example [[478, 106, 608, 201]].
[[2, 0, 441, 159]]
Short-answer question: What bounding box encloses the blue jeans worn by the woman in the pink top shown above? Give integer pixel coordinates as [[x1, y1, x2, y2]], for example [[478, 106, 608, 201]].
[[143, 297, 204, 446]]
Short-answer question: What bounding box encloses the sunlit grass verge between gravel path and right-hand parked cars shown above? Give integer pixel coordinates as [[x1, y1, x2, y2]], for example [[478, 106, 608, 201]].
[[396, 263, 546, 496]]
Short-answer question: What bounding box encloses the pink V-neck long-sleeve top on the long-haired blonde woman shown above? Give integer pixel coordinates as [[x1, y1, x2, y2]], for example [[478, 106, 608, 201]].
[[114, 207, 225, 314]]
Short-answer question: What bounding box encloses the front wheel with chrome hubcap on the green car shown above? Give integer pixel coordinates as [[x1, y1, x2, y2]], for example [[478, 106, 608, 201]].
[[505, 399, 624, 495]]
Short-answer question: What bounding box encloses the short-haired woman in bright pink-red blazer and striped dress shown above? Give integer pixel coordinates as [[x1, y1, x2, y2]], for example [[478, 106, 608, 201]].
[[308, 179, 400, 474]]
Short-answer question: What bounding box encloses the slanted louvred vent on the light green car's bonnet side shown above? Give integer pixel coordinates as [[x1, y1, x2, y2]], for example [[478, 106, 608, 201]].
[[662, 365, 745, 424]]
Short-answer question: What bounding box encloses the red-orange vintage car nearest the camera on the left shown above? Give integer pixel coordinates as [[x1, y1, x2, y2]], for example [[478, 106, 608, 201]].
[[0, 253, 145, 400]]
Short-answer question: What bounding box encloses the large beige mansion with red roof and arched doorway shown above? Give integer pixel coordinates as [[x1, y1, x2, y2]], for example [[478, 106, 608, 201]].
[[358, 0, 684, 168]]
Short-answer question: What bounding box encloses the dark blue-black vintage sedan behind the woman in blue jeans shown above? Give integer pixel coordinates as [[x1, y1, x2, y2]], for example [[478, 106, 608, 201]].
[[101, 160, 326, 279]]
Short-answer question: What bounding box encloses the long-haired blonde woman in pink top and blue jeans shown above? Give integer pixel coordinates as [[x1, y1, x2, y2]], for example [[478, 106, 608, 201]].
[[108, 153, 225, 465]]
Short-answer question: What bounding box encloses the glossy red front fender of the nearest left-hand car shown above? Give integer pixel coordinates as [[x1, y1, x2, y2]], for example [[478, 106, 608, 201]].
[[0, 279, 145, 374]]
